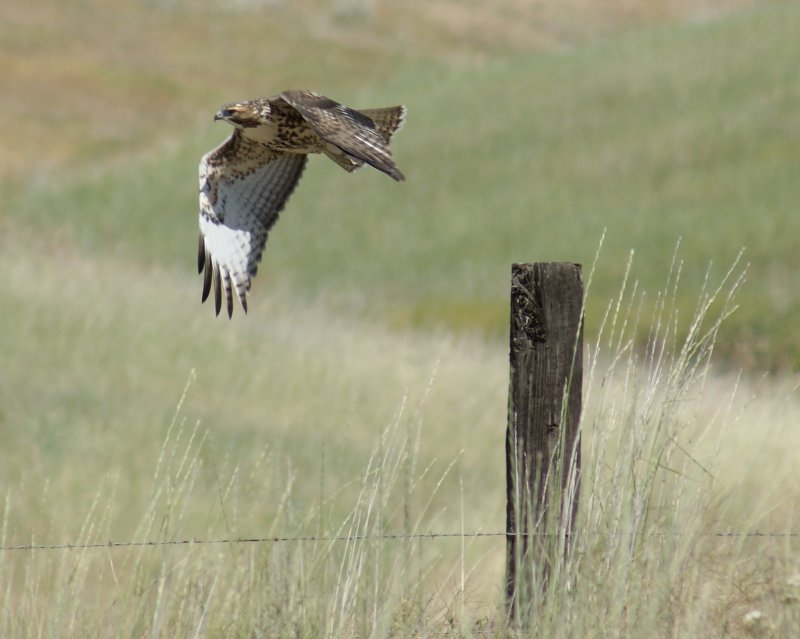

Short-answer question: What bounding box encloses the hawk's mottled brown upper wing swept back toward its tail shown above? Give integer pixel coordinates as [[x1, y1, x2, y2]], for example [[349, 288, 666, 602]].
[[280, 91, 405, 182]]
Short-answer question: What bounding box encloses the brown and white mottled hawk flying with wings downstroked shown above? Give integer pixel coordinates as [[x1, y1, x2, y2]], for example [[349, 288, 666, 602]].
[[197, 91, 406, 317]]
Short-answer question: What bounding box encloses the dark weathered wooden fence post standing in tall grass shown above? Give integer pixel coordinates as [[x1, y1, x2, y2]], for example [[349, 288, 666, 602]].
[[506, 262, 583, 620]]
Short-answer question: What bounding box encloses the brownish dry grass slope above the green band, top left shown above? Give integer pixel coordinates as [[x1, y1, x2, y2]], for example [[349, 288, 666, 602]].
[[0, 0, 768, 178]]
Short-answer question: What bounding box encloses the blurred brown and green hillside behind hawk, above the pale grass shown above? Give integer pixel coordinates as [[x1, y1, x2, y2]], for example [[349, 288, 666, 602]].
[[0, 0, 800, 369]]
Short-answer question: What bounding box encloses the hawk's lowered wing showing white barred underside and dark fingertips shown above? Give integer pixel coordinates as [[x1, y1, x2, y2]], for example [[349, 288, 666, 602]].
[[197, 130, 307, 317]]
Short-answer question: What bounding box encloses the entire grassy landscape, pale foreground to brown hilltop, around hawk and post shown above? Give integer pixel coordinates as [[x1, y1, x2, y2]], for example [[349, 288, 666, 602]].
[[0, 0, 800, 637]]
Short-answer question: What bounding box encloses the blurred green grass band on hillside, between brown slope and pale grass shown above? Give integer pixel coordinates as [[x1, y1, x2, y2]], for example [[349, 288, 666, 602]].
[[9, 5, 800, 367]]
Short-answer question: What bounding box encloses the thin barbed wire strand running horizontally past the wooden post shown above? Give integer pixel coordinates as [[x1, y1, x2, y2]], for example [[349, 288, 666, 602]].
[[0, 530, 800, 552]]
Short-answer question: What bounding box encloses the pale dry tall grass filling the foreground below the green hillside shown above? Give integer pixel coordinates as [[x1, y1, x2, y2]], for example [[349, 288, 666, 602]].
[[0, 228, 800, 637]]
